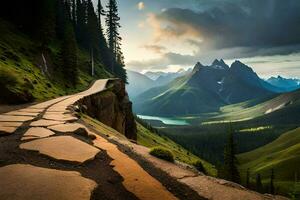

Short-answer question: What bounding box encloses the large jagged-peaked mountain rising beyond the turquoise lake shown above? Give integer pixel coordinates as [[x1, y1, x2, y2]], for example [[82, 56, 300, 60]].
[[133, 59, 280, 116]]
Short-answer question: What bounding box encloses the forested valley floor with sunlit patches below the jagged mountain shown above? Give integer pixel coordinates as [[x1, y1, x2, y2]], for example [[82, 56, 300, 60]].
[[152, 90, 300, 166]]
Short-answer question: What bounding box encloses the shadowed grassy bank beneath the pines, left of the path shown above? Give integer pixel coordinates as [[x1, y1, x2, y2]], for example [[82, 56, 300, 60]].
[[0, 19, 109, 101]]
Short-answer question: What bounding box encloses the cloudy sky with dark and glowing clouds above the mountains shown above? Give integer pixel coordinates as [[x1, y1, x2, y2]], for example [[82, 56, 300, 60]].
[[97, 0, 300, 77]]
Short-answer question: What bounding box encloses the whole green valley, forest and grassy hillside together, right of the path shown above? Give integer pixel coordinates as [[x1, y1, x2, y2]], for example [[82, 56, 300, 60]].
[[136, 67, 300, 195]]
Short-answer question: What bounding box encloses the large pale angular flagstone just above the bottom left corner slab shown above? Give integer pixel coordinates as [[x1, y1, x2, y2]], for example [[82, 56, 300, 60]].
[[20, 136, 100, 163]]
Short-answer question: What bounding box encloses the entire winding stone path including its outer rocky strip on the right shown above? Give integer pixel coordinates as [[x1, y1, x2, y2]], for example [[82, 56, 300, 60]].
[[0, 80, 284, 200]]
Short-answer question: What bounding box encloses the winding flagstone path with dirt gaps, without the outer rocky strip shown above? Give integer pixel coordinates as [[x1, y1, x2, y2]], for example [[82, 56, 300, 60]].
[[0, 80, 183, 200]]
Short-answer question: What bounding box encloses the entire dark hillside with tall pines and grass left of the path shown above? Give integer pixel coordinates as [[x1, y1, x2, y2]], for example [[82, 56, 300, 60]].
[[0, 0, 127, 103]]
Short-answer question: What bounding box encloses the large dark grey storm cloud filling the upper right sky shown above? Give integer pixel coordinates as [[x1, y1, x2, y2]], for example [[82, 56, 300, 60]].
[[158, 0, 300, 50]]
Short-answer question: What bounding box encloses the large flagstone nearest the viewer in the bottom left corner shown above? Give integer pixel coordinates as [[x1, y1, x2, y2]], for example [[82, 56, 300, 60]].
[[0, 164, 97, 200]]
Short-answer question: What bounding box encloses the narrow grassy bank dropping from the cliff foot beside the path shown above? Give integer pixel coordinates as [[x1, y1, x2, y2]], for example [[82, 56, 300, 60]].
[[137, 123, 216, 176]]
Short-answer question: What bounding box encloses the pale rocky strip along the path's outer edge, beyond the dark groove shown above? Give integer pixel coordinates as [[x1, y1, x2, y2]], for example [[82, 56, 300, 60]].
[[131, 144, 287, 200]]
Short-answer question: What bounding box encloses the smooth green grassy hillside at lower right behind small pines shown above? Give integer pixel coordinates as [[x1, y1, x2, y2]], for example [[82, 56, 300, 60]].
[[238, 128, 300, 195]]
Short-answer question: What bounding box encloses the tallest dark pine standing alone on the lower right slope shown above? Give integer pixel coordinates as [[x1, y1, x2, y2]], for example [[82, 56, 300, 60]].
[[224, 125, 240, 183]]
